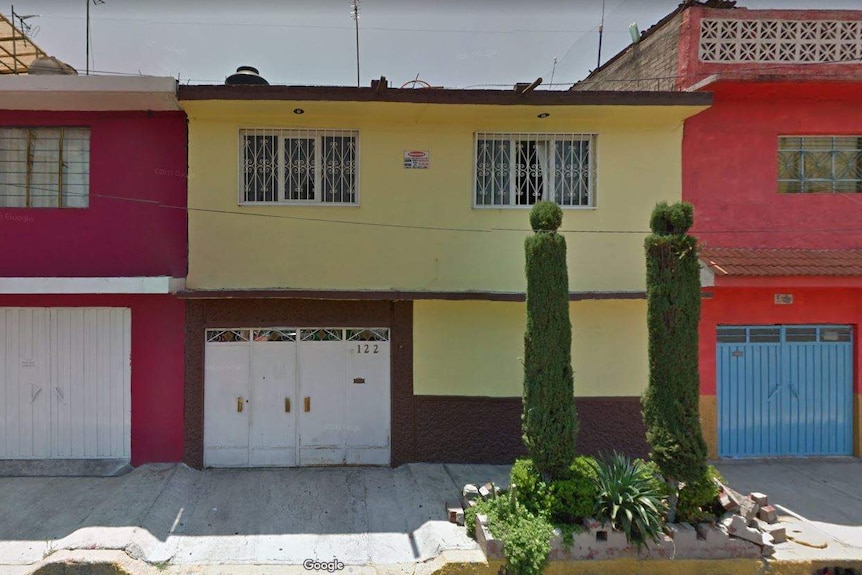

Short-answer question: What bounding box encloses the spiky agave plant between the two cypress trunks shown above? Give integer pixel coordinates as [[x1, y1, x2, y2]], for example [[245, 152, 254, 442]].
[[594, 453, 665, 549]]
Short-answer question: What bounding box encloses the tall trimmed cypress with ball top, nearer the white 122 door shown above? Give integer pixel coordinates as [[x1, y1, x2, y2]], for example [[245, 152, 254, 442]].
[[522, 202, 578, 479]]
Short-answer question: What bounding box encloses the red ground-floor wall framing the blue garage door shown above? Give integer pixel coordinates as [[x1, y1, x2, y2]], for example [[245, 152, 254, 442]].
[[699, 287, 862, 395]]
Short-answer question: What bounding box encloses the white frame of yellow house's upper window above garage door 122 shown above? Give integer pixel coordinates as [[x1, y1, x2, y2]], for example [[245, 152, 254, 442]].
[[237, 127, 361, 207]]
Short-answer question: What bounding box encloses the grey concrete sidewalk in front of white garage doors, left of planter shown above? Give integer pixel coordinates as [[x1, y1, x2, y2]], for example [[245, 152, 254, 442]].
[[0, 464, 509, 574]]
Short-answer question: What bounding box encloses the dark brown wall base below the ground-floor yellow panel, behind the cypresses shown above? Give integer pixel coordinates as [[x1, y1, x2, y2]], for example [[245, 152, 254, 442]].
[[415, 395, 649, 463]]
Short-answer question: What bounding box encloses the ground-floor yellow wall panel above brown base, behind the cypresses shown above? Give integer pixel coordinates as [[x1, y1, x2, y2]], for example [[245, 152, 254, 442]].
[[413, 300, 648, 397]]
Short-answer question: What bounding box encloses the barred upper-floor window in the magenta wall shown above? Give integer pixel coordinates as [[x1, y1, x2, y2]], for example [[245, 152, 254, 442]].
[[0, 125, 92, 210]]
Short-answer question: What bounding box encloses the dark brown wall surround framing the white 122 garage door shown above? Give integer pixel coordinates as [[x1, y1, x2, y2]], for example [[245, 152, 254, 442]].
[[183, 299, 415, 468]]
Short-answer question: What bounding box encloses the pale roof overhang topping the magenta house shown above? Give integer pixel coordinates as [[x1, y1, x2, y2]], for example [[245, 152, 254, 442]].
[[0, 75, 181, 111]]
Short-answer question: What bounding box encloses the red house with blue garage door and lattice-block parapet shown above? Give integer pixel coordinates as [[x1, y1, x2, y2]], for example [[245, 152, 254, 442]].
[[572, 0, 862, 457]]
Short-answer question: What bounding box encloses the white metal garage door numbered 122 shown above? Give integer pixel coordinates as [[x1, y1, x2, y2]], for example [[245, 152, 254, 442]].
[[204, 328, 390, 467]]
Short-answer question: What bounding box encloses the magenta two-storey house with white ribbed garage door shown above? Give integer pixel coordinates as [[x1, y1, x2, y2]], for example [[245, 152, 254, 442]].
[[0, 75, 187, 472]]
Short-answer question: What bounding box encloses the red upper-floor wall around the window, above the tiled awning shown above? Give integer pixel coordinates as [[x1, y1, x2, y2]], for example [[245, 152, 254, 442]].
[[682, 83, 862, 249]]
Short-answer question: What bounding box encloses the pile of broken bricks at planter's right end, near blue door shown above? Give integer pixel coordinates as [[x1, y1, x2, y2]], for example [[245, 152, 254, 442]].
[[718, 482, 787, 557]]
